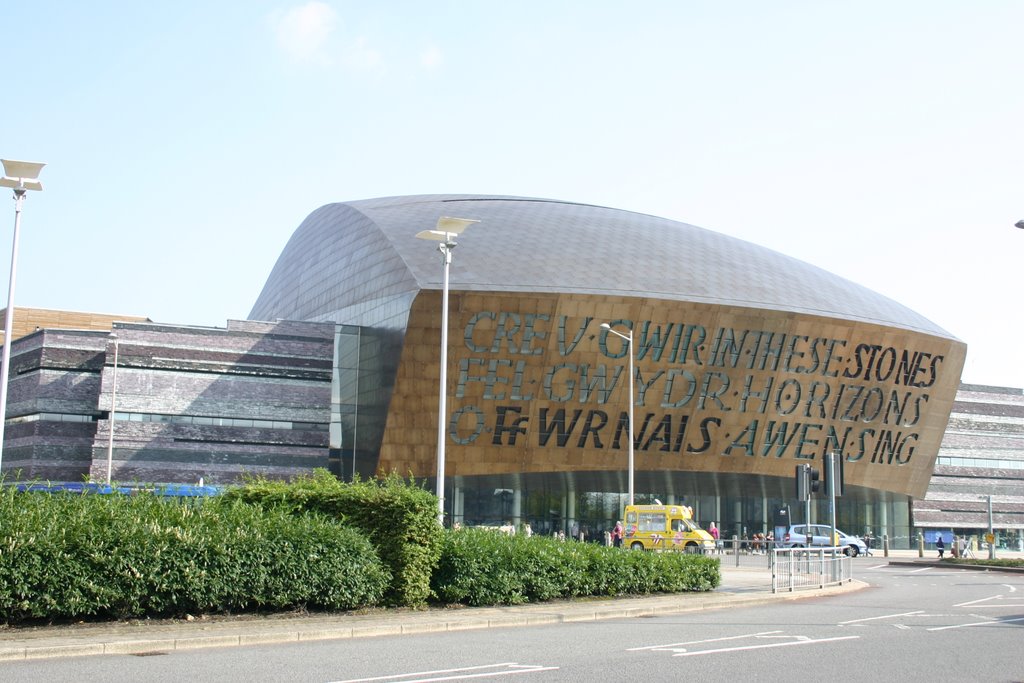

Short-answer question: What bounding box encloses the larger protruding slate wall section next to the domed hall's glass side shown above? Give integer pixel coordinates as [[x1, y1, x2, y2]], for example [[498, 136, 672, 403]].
[[90, 321, 338, 483]]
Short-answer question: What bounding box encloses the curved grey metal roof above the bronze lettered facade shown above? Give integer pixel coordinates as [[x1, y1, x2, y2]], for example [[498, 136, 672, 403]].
[[250, 195, 952, 338]]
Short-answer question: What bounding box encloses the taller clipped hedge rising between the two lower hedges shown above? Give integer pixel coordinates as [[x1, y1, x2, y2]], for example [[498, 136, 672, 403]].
[[224, 469, 442, 606]]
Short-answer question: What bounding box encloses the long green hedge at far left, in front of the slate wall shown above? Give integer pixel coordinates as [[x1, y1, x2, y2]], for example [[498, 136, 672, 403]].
[[0, 487, 390, 623]]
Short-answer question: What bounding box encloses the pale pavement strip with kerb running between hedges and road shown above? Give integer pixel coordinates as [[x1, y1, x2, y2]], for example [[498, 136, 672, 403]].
[[0, 556, 864, 661]]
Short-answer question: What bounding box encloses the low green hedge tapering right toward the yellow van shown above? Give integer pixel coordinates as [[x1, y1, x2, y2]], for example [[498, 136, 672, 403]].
[[432, 528, 721, 606]]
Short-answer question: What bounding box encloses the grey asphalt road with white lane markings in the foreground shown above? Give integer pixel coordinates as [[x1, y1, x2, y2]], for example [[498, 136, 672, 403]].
[[0, 558, 1024, 683]]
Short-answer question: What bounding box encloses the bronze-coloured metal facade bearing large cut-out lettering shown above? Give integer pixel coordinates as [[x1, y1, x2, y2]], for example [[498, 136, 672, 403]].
[[380, 292, 966, 497]]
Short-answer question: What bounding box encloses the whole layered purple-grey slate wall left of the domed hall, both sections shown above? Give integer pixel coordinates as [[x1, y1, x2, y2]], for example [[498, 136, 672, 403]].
[[3, 321, 339, 483]]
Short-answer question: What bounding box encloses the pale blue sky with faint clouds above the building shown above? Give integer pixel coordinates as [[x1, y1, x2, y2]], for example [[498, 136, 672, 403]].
[[0, 0, 1024, 387]]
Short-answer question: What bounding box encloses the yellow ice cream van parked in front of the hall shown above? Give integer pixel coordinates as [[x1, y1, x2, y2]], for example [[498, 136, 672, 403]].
[[623, 505, 715, 553]]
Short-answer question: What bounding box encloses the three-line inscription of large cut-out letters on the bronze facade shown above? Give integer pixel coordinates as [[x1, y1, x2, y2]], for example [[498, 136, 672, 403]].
[[449, 311, 944, 473]]
